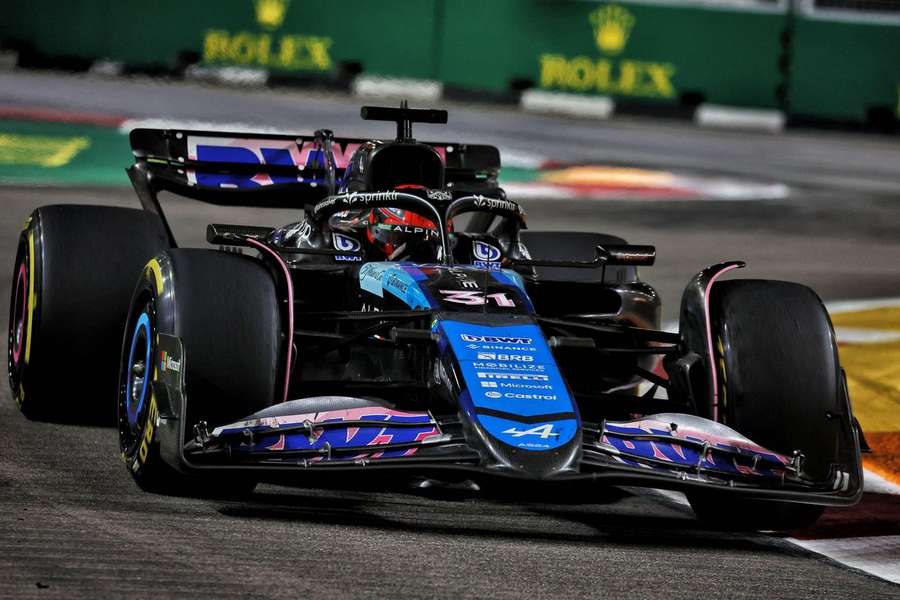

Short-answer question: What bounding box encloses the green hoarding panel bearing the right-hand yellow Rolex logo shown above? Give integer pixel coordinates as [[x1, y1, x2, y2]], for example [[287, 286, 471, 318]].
[[440, 0, 785, 108]]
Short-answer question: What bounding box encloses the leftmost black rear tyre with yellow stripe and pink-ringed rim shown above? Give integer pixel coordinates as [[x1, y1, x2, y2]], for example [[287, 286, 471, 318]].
[[7, 205, 169, 424]]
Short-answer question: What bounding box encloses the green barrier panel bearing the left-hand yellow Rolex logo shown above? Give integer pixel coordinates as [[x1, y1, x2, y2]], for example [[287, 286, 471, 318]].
[[0, 0, 438, 79]]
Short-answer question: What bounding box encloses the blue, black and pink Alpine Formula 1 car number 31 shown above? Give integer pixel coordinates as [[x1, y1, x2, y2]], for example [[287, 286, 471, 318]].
[[9, 103, 862, 528]]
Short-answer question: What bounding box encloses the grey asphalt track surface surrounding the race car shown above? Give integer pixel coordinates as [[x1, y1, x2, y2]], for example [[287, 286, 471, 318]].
[[0, 73, 900, 598]]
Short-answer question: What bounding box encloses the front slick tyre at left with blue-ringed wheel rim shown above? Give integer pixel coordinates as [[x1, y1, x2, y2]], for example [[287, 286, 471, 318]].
[[118, 249, 281, 497]]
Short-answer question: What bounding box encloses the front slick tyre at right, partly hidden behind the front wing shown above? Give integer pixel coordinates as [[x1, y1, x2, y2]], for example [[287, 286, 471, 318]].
[[688, 280, 844, 529]]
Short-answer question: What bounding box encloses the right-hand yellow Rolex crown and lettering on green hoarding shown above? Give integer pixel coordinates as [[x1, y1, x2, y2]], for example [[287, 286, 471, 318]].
[[539, 4, 677, 98]]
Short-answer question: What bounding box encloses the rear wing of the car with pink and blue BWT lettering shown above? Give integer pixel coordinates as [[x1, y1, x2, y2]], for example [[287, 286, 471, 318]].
[[128, 129, 500, 212]]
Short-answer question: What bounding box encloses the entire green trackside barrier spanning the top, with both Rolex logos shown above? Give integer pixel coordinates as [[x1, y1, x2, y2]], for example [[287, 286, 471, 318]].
[[0, 0, 900, 122]]
